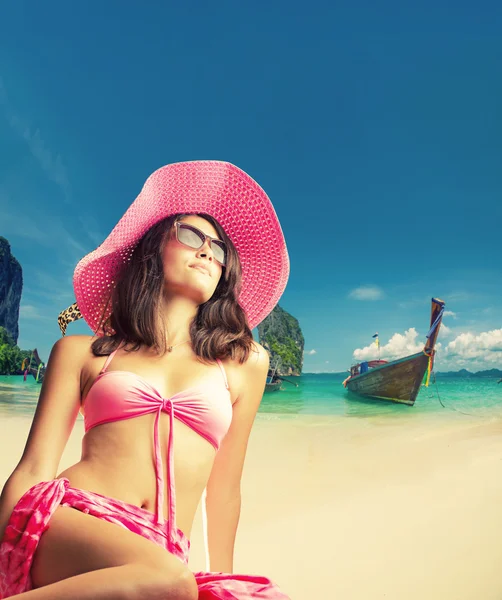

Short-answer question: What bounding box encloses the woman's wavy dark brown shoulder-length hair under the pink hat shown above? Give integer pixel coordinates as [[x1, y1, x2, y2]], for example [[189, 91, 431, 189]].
[[92, 213, 253, 363]]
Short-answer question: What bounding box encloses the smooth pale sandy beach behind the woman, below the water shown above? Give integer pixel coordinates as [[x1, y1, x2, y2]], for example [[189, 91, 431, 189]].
[[0, 411, 502, 600]]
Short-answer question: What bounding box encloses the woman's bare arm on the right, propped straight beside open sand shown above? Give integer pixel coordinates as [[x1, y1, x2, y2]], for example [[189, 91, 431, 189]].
[[206, 342, 269, 573]]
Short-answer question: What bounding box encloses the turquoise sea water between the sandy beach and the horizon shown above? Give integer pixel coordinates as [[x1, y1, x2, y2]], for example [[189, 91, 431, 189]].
[[0, 373, 502, 417]]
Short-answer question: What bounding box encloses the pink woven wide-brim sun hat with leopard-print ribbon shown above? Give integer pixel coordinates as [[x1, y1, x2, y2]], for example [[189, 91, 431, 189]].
[[58, 160, 289, 335]]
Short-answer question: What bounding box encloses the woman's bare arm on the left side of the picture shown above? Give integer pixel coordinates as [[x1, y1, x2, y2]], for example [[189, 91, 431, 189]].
[[0, 336, 89, 540]]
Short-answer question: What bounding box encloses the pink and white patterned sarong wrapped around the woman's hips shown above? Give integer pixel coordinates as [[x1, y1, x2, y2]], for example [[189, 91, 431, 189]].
[[0, 478, 289, 600]]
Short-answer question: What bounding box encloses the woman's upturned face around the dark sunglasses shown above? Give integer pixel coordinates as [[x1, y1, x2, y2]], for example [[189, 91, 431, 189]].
[[162, 215, 223, 305]]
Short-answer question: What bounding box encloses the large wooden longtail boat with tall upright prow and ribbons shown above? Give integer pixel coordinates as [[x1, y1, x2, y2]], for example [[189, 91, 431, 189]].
[[343, 298, 444, 406]]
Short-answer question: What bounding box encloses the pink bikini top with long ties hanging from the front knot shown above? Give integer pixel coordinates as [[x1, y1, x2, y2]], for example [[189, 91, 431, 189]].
[[82, 348, 232, 539]]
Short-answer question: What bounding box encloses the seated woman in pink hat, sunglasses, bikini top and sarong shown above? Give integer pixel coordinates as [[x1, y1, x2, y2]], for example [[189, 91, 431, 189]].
[[0, 161, 289, 600]]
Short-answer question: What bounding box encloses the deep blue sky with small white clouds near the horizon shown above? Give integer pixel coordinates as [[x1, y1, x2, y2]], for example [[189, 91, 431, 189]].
[[0, 0, 502, 372]]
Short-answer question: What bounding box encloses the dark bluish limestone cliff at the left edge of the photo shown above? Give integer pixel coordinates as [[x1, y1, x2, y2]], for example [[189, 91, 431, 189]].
[[0, 236, 23, 344]]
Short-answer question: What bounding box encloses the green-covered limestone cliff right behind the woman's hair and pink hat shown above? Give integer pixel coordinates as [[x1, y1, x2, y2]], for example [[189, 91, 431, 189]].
[[258, 305, 305, 375]]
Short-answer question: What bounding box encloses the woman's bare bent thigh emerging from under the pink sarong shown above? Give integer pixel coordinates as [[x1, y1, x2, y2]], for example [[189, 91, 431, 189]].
[[31, 506, 188, 587]]
